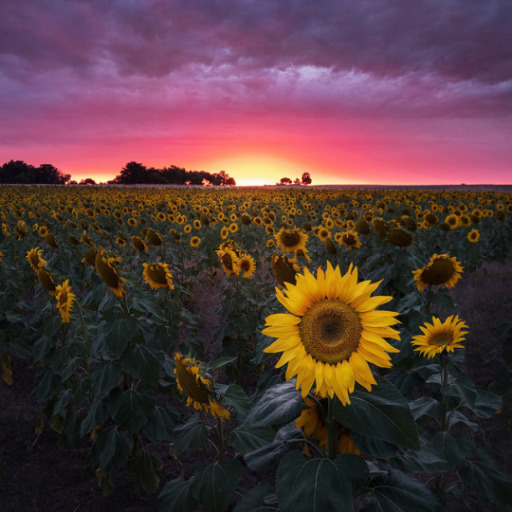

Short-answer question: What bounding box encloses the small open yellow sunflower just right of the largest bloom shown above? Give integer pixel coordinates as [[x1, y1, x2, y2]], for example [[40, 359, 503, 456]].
[[411, 315, 468, 359]]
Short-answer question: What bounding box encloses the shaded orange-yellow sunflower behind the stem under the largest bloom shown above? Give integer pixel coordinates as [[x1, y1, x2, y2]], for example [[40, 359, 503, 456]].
[[295, 397, 361, 455]]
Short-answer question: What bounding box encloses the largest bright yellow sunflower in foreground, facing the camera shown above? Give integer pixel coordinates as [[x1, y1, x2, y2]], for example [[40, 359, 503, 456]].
[[262, 262, 400, 405]]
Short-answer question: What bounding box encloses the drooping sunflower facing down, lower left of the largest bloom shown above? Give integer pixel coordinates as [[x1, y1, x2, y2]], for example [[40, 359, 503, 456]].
[[174, 352, 230, 420]]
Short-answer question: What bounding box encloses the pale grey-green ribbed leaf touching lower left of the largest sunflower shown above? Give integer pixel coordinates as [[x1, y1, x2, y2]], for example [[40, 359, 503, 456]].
[[244, 379, 304, 426]]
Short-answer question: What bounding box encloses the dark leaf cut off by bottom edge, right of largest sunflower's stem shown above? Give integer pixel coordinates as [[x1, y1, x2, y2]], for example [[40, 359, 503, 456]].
[[364, 468, 439, 512]]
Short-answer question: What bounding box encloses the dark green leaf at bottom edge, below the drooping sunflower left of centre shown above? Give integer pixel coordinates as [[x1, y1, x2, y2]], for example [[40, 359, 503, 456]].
[[192, 459, 242, 512]]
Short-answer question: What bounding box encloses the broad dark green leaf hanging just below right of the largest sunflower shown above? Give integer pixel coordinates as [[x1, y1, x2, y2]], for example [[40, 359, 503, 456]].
[[334, 377, 419, 449]]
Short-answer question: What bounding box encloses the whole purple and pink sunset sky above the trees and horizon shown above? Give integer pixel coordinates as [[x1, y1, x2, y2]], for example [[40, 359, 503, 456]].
[[0, 0, 512, 185]]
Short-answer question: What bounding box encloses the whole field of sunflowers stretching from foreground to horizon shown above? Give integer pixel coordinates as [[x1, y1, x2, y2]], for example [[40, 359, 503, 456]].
[[0, 186, 512, 512]]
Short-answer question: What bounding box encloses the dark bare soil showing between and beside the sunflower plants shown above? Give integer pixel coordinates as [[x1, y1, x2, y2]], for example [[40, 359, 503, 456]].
[[0, 263, 512, 512]]
